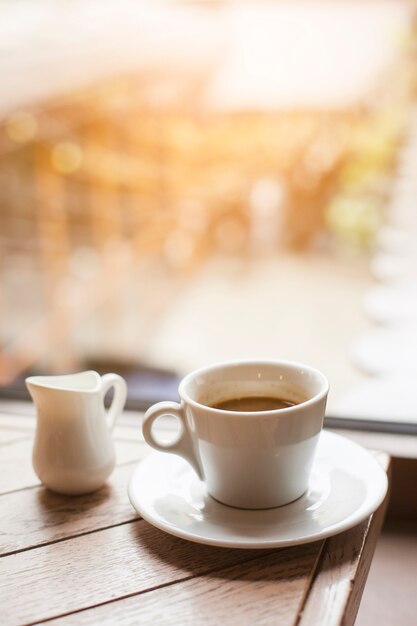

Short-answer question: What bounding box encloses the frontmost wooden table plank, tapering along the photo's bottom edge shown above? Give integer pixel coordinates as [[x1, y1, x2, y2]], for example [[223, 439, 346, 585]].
[[41, 542, 323, 626]]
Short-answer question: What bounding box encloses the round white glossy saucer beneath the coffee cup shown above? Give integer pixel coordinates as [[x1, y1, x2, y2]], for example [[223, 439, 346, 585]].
[[128, 432, 388, 548]]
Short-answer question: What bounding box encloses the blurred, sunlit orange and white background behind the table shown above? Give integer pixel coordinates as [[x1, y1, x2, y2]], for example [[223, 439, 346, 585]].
[[0, 0, 417, 424]]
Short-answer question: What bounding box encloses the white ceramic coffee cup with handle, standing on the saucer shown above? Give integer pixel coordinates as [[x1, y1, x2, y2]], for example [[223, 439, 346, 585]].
[[143, 360, 328, 509]]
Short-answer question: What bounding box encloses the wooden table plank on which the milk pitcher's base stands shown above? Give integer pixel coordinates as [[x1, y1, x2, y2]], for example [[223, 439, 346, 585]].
[[0, 463, 137, 556]]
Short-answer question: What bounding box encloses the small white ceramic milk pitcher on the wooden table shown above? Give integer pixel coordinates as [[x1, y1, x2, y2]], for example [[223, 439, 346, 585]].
[[26, 371, 127, 495]]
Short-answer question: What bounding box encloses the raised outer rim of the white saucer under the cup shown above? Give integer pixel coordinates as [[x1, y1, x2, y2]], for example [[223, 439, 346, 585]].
[[127, 430, 388, 550]]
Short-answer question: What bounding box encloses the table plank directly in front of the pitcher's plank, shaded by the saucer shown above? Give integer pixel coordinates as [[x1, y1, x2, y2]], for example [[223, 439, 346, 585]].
[[0, 520, 286, 626]]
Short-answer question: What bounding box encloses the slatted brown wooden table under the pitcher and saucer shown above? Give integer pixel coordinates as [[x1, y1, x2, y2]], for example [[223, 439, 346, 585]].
[[0, 403, 389, 626]]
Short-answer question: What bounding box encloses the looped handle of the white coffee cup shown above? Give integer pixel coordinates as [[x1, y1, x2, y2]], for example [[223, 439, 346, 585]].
[[142, 402, 204, 480]]
